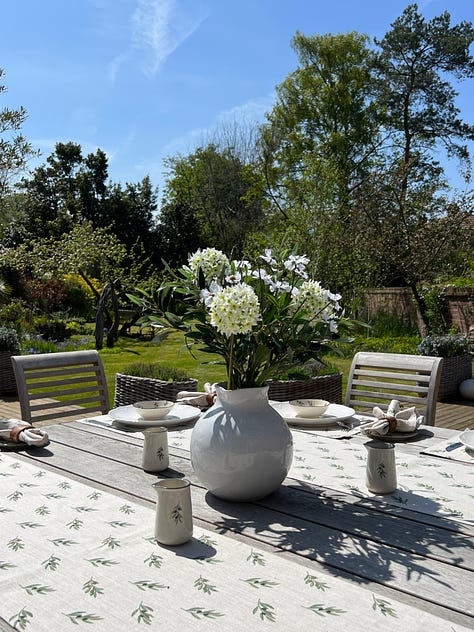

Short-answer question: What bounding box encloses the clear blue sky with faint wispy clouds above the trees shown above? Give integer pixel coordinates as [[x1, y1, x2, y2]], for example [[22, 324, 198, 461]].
[[0, 0, 474, 195]]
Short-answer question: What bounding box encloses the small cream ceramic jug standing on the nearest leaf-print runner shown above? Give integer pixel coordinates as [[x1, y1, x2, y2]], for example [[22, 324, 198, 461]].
[[153, 478, 193, 546]]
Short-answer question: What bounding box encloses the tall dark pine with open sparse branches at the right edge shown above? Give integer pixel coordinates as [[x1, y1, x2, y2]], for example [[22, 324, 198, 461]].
[[359, 4, 474, 331]]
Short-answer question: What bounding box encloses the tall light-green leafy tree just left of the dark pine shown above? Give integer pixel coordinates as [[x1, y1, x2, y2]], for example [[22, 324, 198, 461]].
[[261, 33, 381, 294]]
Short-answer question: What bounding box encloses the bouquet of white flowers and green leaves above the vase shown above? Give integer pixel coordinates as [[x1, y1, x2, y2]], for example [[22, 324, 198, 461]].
[[129, 248, 342, 389]]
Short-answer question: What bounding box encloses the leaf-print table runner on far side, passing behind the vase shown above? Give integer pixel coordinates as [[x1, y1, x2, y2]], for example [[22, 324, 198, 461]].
[[83, 416, 474, 525]]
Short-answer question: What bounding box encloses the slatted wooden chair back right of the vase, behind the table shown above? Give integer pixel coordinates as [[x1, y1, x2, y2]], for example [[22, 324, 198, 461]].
[[346, 352, 442, 426]]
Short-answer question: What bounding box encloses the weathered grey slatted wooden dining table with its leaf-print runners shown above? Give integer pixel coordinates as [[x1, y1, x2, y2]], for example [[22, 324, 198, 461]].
[[0, 406, 474, 632]]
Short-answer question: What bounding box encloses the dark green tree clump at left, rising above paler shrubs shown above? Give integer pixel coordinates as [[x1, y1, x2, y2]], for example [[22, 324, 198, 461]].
[[9, 142, 157, 250]]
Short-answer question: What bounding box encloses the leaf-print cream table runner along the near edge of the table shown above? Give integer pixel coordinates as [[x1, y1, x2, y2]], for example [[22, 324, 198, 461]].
[[0, 454, 467, 632]]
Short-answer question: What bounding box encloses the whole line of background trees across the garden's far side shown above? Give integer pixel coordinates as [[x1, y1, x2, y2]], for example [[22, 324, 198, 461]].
[[0, 4, 474, 330]]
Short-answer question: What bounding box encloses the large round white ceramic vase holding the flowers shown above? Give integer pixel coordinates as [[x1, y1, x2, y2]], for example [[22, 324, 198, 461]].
[[191, 386, 293, 501]]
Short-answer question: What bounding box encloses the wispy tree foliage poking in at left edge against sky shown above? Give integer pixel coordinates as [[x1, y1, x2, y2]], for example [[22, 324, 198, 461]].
[[0, 68, 39, 204]]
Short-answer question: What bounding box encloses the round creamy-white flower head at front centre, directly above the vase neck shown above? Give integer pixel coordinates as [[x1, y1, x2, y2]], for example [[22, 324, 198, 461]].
[[209, 283, 260, 336]]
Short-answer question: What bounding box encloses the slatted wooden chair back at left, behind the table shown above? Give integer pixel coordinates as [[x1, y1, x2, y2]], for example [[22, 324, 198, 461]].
[[12, 350, 110, 425]]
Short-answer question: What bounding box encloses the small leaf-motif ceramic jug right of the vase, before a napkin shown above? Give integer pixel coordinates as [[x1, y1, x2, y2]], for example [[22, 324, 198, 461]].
[[364, 439, 397, 494]]
